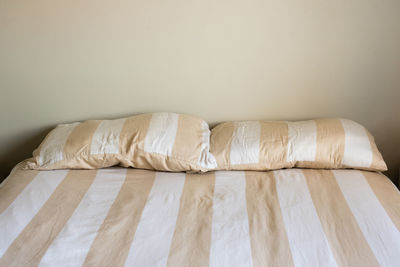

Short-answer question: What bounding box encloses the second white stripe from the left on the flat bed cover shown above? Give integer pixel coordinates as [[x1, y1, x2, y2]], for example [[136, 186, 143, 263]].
[[40, 169, 126, 266]]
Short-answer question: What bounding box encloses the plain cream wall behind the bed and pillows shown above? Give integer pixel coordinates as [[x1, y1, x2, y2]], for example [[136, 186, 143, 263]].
[[0, 0, 400, 183]]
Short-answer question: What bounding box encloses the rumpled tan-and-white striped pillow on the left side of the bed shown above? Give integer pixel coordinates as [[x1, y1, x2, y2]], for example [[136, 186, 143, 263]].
[[27, 112, 216, 171]]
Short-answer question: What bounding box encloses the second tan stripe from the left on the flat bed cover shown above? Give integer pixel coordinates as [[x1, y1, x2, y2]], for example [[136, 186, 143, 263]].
[[0, 170, 96, 266]]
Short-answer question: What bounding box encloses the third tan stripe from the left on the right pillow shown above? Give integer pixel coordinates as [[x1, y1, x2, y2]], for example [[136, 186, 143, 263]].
[[314, 119, 345, 168]]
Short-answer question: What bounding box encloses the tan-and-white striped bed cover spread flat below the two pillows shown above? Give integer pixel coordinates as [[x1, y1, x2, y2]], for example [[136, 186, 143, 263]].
[[0, 168, 400, 266]]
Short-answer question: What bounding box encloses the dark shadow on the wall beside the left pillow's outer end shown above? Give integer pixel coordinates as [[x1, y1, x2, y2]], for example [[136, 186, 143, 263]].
[[0, 127, 52, 182]]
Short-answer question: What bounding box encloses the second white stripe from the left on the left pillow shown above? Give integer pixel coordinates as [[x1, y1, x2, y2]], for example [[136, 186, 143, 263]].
[[90, 119, 126, 155]]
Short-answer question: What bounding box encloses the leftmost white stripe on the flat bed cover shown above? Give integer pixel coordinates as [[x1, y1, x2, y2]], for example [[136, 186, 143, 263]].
[[0, 170, 68, 257]]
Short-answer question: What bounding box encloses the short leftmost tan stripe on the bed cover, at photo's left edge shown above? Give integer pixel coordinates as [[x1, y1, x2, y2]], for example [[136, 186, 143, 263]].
[[0, 170, 39, 213]]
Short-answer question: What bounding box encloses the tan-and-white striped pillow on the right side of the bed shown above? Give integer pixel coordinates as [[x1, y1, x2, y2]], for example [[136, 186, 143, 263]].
[[210, 119, 387, 171]]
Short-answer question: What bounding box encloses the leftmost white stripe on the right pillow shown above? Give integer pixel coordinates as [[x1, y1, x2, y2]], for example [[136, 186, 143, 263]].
[[230, 121, 261, 165]]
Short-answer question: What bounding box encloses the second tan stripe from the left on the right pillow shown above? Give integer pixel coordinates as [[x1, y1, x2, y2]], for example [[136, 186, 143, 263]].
[[260, 122, 291, 169]]
